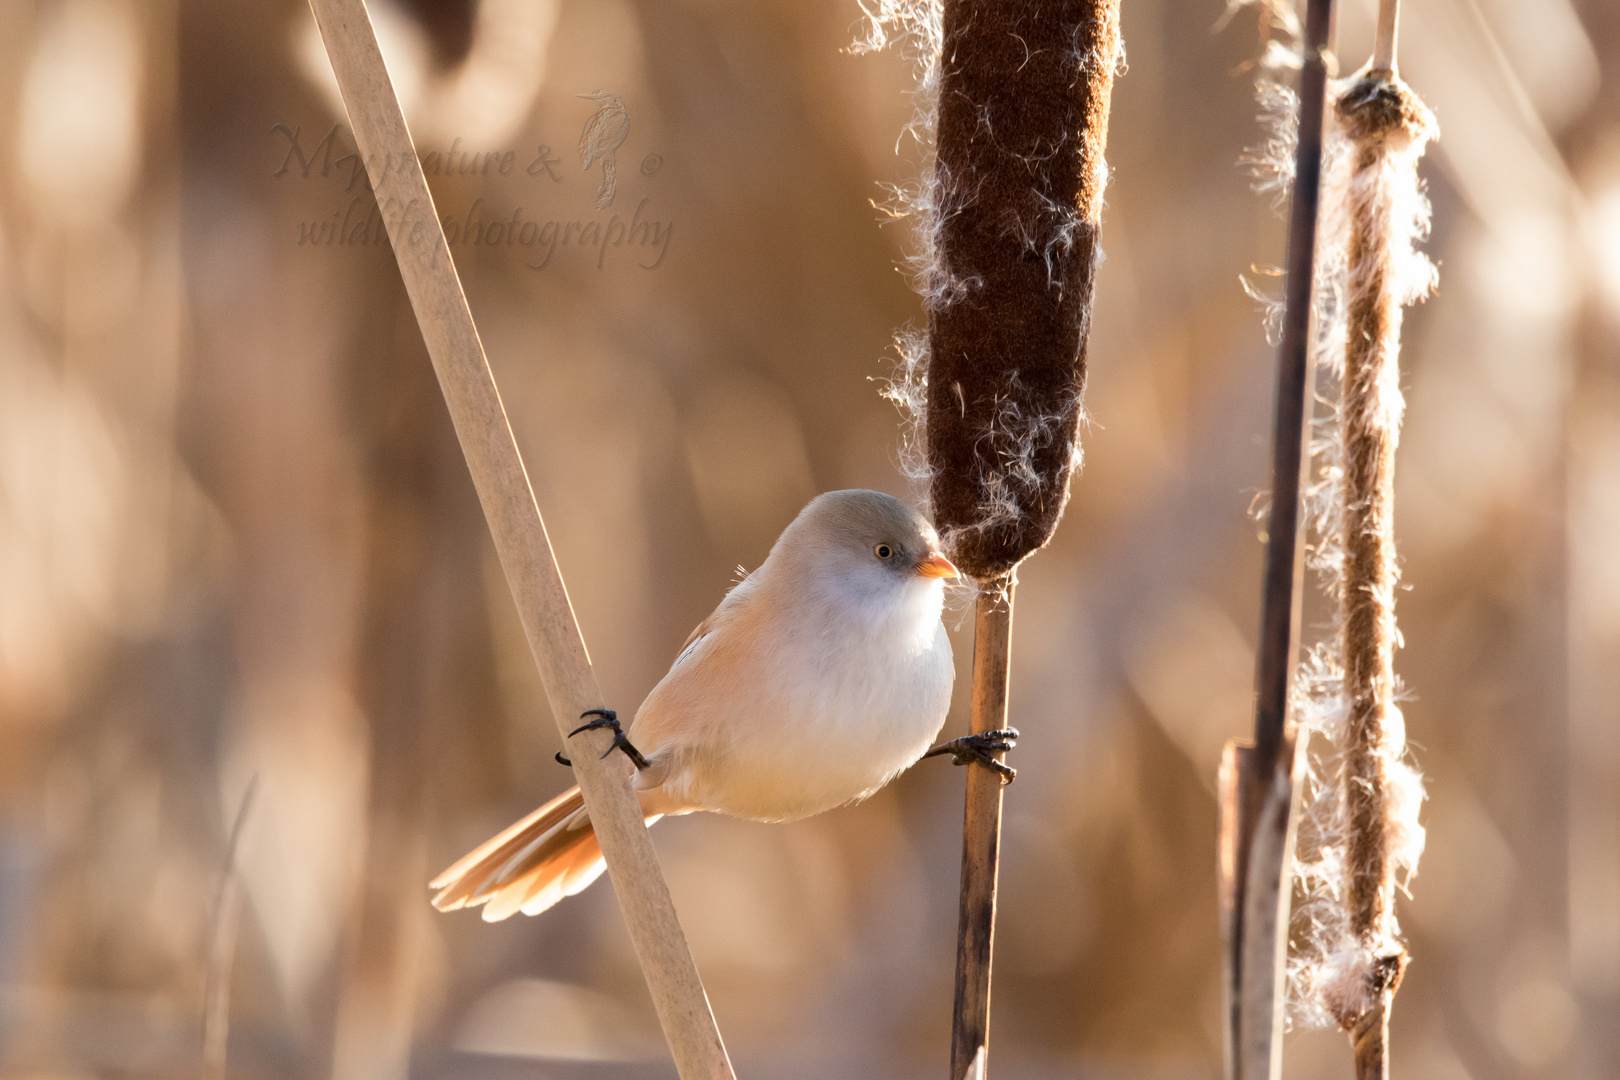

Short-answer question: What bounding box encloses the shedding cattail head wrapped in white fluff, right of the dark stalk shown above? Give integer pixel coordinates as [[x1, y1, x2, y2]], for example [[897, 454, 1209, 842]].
[[1293, 61, 1435, 1036]]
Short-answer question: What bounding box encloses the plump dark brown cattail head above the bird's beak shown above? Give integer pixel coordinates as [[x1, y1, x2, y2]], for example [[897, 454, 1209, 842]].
[[927, 0, 1123, 580]]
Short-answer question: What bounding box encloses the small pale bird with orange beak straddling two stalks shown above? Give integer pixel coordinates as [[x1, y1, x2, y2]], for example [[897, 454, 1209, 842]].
[[429, 491, 1017, 923]]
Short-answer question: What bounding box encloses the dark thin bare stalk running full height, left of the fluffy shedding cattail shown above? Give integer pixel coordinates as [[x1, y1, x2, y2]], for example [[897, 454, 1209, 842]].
[[1223, 0, 1333, 1080]]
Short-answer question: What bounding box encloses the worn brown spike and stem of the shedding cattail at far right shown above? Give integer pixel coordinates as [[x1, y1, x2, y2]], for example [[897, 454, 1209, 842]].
[[1328, 29, 1434, 1080]]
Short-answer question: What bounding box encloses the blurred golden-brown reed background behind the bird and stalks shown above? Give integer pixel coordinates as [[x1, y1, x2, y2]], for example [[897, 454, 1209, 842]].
[[0, 0, 1620, 1080]]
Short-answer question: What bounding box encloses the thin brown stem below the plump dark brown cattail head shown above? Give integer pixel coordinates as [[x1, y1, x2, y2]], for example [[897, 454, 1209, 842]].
[[951, 573, 1016, 1080]]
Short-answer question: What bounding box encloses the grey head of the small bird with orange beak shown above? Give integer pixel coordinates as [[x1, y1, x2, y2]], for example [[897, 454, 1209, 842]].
[[766, 491, 957, 620]]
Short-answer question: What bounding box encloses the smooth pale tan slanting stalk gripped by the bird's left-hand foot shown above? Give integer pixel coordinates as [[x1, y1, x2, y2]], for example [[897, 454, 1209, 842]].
[[311, 0, 732, 1080]]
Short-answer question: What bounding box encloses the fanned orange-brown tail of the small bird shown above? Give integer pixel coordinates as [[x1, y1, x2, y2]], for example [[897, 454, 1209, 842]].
[[428, 787, 661, 923]]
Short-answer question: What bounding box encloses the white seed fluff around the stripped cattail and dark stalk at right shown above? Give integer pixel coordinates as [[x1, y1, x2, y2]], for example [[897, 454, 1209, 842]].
[[1230, 0, 1437, 1027]]
